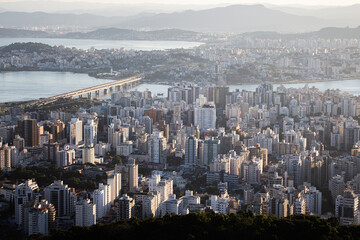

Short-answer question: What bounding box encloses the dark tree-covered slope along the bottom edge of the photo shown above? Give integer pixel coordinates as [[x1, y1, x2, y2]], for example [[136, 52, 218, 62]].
[[28, 212, 360, 240]]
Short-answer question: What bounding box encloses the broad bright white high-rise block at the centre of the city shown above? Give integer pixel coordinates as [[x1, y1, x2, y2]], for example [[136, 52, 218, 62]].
[[194, 104, 216, 129]]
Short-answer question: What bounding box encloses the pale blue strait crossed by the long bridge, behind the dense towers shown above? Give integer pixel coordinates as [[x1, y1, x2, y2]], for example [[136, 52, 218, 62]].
[[0, 72, 360, 102]]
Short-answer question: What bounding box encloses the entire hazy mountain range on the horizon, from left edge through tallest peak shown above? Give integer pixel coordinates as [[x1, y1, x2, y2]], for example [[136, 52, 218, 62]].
[[0, 5, 342, 33]]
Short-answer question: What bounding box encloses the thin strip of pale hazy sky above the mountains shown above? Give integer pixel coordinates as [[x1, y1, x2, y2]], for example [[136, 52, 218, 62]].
[[0, 0, 360, 7]]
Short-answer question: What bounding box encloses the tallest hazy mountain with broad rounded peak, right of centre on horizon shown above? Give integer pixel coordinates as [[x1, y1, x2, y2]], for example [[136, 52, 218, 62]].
[[119, 5, 334, 33]]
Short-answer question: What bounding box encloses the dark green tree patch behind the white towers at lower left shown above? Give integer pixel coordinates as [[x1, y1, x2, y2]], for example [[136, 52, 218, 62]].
[[2, 166, 106, 191]]
